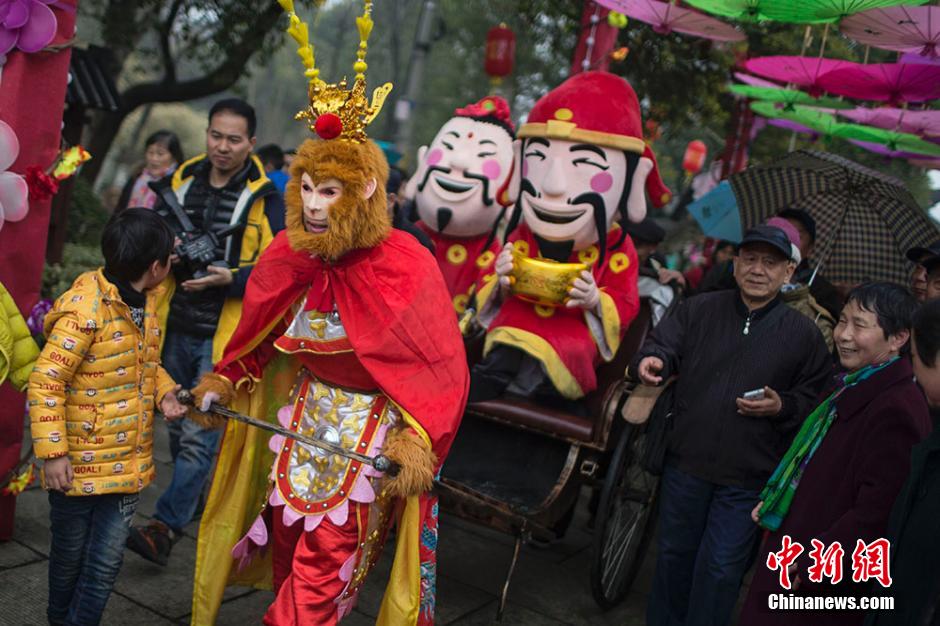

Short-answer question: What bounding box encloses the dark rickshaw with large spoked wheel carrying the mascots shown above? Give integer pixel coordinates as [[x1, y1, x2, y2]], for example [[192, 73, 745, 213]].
[[436, 299, 658, 621]]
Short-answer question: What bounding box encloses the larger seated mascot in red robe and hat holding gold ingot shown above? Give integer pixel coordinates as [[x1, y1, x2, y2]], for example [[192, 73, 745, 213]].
[[470, 72, 669, 406]]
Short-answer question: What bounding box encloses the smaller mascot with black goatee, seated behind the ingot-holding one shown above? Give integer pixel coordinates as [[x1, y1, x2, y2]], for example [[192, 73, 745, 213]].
[[405, 96, 515, 315]]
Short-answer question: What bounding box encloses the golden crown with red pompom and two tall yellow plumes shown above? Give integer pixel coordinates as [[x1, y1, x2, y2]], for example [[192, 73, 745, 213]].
[[277, 0, 392, 143]]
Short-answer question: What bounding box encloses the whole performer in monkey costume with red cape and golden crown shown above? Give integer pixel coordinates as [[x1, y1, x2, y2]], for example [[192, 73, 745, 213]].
[[191, 0, 469, 626]]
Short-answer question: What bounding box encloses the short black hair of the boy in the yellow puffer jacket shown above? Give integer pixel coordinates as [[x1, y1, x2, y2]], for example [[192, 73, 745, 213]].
[[101, 207, 175, 282]]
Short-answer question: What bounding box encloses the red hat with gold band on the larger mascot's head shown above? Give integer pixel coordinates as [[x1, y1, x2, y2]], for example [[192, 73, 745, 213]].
[[519, 72, 672, 208]]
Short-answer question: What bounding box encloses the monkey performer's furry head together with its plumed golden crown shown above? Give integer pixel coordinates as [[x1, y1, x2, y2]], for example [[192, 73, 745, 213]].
[[278, 0, 392, 261]]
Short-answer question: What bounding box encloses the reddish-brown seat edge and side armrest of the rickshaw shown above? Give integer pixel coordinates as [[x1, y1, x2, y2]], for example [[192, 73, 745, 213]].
[[467, 298, 650, 447]]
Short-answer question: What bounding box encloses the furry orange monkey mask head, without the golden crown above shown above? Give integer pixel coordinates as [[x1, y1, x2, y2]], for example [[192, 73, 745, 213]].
[[284, 139, 391, 260]]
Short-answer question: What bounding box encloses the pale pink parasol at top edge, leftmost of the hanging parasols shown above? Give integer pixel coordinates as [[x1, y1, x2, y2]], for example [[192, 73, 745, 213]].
[[597, 0, 747, 41]]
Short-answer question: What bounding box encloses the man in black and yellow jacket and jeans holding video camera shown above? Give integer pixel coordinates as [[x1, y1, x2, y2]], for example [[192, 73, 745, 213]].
[[127, 98, 284, 565]]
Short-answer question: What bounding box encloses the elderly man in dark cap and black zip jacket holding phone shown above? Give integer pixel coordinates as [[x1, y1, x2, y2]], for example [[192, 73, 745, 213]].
[[632, 226, 831, 626]]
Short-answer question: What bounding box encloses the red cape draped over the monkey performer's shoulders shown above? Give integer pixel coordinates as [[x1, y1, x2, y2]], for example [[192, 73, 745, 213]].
[[215, 230, 470, 462]]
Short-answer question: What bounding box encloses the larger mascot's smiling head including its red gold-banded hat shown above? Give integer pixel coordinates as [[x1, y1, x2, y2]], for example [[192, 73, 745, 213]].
[[507, 72, 670, 260]]
